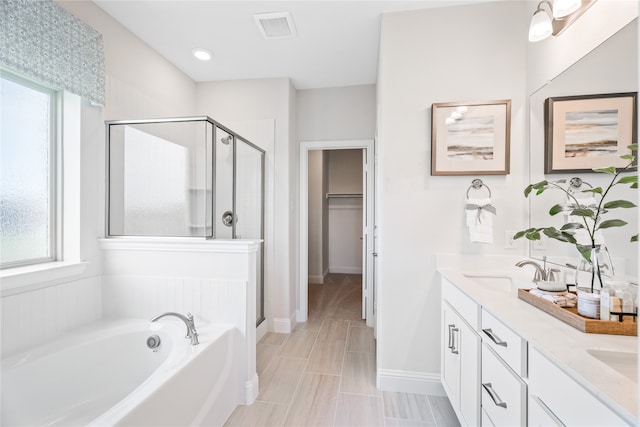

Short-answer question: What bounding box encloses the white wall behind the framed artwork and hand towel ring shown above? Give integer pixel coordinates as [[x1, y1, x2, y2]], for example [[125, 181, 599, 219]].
[[377, 2, 529, 390]]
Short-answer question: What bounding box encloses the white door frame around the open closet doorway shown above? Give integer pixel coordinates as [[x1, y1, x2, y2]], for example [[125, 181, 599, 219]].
[[297, 140, 375, 327]]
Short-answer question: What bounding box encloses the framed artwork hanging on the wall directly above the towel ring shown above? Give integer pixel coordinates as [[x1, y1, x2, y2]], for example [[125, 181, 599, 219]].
[[431, 99, 511, 175]]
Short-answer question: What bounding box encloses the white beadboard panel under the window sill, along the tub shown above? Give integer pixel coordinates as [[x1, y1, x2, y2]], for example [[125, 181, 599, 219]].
[[1, 276, 102, 357]]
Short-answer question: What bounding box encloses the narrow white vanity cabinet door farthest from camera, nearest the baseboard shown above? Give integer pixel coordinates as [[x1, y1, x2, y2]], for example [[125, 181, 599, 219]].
[[442, 302, 460, 408]]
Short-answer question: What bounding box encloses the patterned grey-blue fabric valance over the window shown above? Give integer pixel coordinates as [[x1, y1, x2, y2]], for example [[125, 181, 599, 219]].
[[0, 0, 104, 105]]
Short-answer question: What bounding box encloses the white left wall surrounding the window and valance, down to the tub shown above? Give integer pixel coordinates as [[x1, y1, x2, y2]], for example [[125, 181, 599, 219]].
[[2, 1, 195, 356]]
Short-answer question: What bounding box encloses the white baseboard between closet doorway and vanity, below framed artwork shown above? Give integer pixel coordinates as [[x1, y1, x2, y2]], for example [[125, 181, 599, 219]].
[[376, 369, 446, 396]]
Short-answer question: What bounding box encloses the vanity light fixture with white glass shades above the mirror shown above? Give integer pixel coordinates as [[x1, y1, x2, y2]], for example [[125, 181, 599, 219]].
[[529, 0, 596, 42]]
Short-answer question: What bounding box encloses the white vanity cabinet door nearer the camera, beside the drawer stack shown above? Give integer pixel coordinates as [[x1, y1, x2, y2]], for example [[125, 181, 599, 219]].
[[459, 321, 481, 426]]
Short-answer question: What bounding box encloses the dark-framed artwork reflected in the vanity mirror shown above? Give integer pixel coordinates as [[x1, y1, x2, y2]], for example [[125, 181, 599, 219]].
[[544, 92, 638, 173]]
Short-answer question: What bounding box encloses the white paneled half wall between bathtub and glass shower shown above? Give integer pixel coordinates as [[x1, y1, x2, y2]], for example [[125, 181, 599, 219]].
[[100, 238, 260, 404]]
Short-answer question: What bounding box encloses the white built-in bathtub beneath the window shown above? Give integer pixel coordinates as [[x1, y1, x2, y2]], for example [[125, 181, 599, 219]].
[[0, 318, 241, 427]]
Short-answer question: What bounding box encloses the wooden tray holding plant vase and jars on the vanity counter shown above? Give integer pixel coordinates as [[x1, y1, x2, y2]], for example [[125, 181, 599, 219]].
[[518, 289, 638, 336]]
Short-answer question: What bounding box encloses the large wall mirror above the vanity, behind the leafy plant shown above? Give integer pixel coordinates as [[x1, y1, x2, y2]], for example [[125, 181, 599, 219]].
[[529, 19, 640, 282]]
